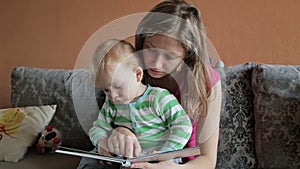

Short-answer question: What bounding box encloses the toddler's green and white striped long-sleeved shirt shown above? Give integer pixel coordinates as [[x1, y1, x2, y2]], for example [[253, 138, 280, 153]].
[[89, 86, 192, 153]]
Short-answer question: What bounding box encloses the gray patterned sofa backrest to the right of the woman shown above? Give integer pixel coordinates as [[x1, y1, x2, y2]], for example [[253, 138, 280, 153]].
[[217, 63, 300, 169]]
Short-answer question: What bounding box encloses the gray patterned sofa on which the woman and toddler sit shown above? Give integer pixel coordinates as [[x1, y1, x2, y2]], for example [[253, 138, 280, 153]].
[[0, 62, 300, 169]]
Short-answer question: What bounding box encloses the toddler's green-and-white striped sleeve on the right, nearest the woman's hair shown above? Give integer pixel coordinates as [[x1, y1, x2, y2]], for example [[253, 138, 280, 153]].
[[155, 90, 192, 151]]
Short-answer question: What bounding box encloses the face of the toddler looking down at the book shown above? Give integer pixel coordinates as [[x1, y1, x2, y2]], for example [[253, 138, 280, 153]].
[[96, 62, 140, 104]]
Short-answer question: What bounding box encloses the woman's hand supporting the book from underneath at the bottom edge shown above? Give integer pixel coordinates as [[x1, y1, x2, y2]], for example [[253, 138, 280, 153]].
[[130, 161, 178, 169]]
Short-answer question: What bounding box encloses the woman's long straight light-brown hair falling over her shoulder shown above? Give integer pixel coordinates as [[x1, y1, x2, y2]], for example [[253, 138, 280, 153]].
[[135, 0, 211, 119]]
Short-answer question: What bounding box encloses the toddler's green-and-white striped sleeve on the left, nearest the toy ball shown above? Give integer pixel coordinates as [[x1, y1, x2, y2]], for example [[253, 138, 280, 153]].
[[89, 100, 112, 146]]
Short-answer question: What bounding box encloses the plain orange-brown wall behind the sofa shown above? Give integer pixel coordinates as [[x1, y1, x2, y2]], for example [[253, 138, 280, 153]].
[[0, 0, 300, 108]]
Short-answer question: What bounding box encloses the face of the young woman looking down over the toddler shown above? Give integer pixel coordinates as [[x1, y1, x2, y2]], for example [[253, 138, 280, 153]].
[[143, 35, 185, 78]]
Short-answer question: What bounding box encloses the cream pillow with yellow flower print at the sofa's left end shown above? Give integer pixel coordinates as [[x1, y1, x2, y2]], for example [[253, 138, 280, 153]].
[[0, 105, 56, 162]]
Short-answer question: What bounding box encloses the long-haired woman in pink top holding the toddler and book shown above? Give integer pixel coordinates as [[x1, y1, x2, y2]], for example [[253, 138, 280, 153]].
[[108, 0, 221, 169]]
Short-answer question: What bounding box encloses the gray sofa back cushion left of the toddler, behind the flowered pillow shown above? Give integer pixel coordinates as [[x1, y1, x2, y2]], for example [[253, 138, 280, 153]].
[[11, 67, 99, 150]]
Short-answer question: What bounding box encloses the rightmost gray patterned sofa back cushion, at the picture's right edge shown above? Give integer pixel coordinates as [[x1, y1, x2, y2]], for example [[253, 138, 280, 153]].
[[252, 65, 300, 169]]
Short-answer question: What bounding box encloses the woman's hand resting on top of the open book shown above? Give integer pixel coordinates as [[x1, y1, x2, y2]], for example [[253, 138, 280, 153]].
[[108, 127, 141, 158]]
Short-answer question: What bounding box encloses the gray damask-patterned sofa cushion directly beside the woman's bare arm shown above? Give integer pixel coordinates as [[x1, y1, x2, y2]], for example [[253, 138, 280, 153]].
[[217, 63, 257, 169]]
